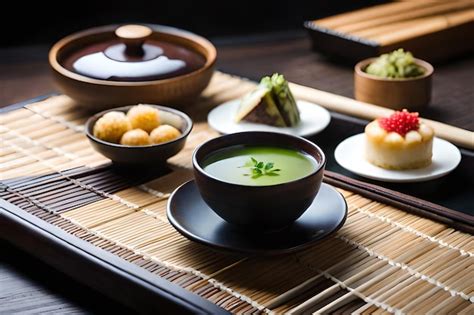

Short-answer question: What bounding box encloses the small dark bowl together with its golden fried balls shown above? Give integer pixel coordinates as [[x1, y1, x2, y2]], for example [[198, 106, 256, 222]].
[[85, 104, 193, 167]]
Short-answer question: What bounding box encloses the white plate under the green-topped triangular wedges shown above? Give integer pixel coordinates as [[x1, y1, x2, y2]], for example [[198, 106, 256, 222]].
[[207, 99, 331, 137]]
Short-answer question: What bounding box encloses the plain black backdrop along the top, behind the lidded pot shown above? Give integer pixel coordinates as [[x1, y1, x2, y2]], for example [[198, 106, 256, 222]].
[[4, 0, 388, 47]]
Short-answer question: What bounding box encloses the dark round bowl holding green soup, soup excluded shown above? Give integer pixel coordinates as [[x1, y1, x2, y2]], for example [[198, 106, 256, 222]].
[[193, 132, 326, 230]]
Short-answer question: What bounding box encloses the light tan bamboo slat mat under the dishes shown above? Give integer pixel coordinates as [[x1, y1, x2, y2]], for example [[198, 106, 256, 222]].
[[0, 73, 474, 314]]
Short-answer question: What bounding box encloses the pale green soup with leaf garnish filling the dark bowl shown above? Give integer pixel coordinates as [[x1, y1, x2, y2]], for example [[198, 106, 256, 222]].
[[203, 146, 318, 186]]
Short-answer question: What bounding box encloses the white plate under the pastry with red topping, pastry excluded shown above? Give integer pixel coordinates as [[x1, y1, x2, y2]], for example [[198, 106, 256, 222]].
[[334, 133, 461, 183]]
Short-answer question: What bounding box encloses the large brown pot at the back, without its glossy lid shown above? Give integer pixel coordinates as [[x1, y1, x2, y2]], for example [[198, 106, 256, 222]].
[[49, 25, 216, 111]]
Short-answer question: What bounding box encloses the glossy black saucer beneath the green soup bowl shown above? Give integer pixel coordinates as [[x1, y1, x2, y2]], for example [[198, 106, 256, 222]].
[[167, 181, 347, 255]]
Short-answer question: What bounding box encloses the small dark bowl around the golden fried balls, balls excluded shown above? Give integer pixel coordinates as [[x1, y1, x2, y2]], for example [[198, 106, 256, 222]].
[[85, 105, 193, 167]]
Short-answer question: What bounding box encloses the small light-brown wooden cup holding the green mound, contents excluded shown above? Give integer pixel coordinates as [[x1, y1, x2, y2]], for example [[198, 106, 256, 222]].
[[354, 58, 433, 111]]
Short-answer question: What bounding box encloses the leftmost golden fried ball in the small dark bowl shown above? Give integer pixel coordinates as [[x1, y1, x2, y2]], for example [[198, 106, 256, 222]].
[[93, 111, 132, 143]]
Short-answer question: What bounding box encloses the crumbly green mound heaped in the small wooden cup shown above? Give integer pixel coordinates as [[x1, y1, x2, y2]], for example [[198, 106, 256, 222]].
[[365, 48, 425, 79]]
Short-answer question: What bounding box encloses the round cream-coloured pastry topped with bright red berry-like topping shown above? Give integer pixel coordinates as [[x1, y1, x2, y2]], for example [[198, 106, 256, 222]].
[[365, 109, 434, 170]]
